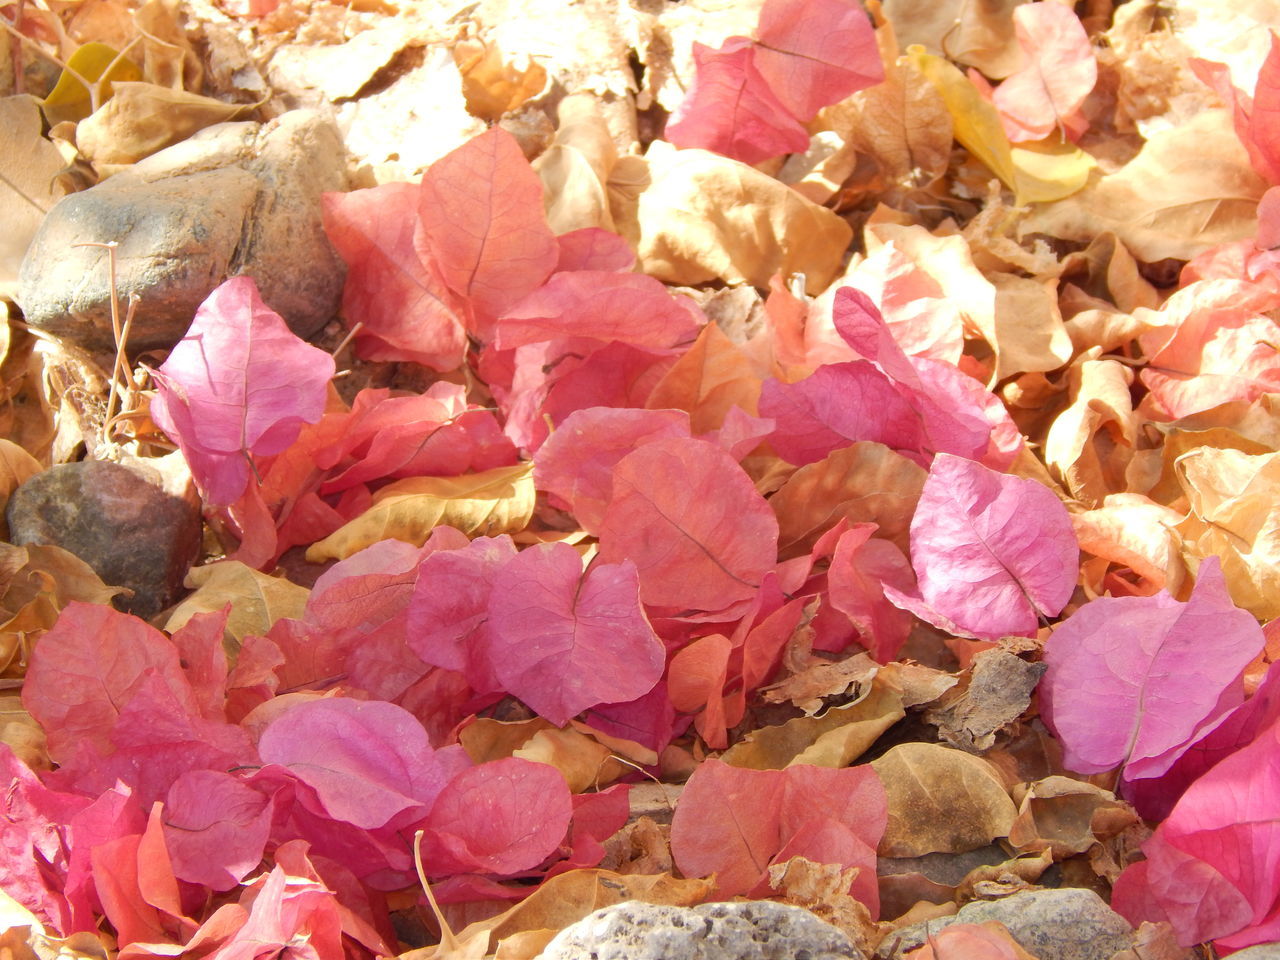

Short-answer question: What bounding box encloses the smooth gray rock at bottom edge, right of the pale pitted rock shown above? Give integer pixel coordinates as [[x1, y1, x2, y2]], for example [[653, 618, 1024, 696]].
[[876, 887, 1133, 960]]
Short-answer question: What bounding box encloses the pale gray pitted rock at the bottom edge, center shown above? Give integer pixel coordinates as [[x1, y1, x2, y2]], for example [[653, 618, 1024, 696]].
[[541, 900, 861, 960]]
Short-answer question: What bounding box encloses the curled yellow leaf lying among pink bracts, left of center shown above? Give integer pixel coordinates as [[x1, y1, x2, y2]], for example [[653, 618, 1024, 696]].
[[307, 463, 535, 563]]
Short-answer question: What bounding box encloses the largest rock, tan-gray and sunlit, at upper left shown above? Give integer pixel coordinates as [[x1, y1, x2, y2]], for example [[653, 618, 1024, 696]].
[[19, 110, 347, 351]]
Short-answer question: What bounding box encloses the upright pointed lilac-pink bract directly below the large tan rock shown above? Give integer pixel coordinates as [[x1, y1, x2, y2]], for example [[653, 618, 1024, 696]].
[[151, 276, 334, 506]]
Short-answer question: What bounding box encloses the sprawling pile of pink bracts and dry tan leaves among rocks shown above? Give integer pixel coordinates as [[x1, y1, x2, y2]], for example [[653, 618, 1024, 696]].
[[0, 0, 1280, 960]]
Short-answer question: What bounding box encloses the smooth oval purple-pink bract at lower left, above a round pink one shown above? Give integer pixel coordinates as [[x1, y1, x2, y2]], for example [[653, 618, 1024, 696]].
[[257, 698, 445, 828]]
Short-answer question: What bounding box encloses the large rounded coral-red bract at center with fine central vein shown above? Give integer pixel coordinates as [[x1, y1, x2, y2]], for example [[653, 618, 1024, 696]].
[[599, 439, 778, 611]]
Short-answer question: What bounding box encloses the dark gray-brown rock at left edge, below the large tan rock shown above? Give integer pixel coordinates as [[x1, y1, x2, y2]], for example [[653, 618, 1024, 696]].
[[5, 460, 201, 617]]
